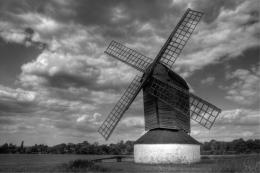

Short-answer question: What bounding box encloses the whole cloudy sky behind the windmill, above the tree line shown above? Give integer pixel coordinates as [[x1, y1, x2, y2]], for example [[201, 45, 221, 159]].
[[0, 0, 260, 145]]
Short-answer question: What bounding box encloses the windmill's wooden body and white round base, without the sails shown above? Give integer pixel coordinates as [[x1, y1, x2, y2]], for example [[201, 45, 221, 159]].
[[134, 64, 200, 163]]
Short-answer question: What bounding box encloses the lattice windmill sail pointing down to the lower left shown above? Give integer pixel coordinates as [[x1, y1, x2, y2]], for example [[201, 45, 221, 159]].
[[98, 75, 142, 140]]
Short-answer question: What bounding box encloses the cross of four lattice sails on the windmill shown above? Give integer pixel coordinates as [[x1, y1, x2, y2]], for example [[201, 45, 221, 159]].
[[98, 9, 221, 140]]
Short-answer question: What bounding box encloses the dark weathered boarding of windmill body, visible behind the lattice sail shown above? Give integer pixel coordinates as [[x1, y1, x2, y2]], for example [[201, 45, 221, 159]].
[[143, 64, 190, 132]]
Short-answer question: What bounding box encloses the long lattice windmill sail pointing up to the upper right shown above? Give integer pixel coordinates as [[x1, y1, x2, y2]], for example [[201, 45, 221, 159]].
[[157, 9, 203, 69]]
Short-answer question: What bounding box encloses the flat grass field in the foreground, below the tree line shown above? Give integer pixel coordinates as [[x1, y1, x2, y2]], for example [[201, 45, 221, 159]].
[[0, 154, 260, 173]]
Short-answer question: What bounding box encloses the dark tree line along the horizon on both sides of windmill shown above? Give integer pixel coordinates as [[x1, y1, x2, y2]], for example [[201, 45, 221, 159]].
[[0, 138, 260, 155]]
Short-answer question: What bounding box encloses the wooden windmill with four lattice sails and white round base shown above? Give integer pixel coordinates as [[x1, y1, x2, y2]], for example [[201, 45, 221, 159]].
[[98, 9, 221, 163]]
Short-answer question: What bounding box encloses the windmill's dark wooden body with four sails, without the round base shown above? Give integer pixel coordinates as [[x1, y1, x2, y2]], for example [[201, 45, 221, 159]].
[[98, 9, 221, 140]]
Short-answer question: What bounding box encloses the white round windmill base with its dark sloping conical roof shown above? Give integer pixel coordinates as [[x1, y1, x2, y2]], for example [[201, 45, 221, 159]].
[[134, 128, 200, 164]]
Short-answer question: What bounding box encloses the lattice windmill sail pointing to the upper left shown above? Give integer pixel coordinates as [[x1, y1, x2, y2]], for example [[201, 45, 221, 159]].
[[105, 41, 153, 72]]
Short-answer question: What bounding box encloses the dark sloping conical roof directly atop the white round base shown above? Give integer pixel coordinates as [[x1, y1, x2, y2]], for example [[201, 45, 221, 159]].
[[135, 128, 200, 145]]
